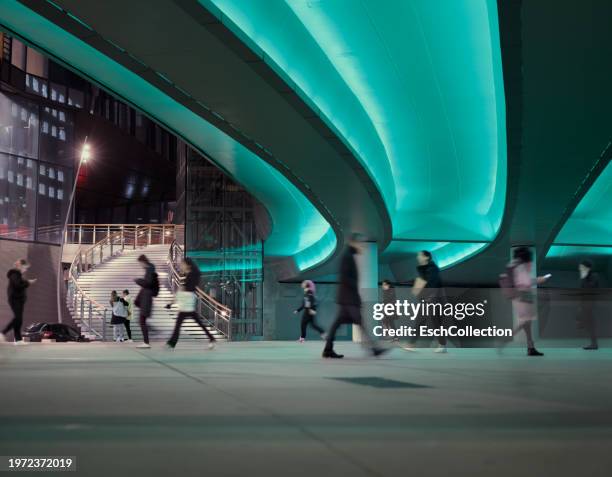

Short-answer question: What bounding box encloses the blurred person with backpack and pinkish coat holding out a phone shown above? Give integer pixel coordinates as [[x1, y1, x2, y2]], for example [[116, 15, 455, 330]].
[[500, 247, 550, 356]]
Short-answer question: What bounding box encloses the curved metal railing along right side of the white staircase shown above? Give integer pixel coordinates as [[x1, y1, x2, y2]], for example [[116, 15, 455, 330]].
[[168, 241, 232, 341]]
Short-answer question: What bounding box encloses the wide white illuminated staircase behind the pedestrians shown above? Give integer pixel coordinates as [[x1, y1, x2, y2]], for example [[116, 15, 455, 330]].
[[68, 244, 225, 341]]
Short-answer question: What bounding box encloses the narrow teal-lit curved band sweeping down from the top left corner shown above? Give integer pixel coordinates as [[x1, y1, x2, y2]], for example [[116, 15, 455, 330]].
[[0, 0, 336, 270]]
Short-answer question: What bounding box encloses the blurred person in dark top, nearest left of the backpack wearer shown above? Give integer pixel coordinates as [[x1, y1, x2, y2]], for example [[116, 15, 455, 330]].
[[404, 250, 447, 353]]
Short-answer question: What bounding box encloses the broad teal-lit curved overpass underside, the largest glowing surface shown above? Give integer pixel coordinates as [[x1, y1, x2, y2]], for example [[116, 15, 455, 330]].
[[206, 0, 506, 260]]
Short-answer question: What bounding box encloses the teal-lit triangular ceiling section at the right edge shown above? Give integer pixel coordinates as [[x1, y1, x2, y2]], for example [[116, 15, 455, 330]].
[[547, 163, 612, 247]]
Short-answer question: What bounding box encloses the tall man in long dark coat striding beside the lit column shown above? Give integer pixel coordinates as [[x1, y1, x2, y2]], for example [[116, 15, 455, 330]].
[[323, 234, 388, 358]]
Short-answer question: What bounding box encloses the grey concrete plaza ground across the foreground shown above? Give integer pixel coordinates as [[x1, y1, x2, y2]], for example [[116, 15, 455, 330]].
[[0, 342, 612, 477]]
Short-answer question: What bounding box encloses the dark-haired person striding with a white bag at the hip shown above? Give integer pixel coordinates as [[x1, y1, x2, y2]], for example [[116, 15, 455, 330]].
[[166, 258, 215, 349]]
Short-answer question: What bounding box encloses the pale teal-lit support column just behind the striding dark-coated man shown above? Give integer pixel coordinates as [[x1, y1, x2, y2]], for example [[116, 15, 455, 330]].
[[353, 242, 378, 343]]
